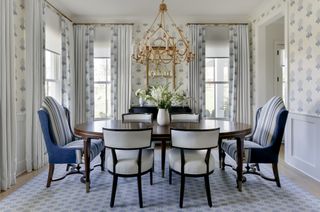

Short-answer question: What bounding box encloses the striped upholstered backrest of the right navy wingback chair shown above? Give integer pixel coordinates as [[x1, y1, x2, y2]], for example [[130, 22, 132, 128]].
[[252, 97, 285, 147]]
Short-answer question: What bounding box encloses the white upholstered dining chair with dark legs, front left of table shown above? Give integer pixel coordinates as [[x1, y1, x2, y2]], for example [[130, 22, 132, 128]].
[[103, 128, 154, 208]]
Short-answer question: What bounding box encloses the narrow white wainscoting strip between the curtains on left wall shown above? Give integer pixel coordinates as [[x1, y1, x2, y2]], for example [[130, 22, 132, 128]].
[[17, 113, 27, 176]]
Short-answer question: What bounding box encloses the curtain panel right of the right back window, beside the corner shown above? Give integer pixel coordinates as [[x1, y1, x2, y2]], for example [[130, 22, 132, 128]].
[[229, 25, 251, 124]]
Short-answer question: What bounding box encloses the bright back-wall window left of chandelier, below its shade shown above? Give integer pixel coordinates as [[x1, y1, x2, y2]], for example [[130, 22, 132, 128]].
[[94, 57, 112, 119]]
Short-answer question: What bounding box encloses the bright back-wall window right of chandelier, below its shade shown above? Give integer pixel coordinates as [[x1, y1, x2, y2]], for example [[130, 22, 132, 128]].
[[205, 57, 229, 119]]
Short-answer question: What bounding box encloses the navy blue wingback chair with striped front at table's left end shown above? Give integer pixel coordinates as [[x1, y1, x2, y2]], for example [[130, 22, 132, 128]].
[[38, 97, 105, 187]]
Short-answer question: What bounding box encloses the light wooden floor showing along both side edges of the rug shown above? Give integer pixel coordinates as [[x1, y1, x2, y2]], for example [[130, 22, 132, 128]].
[[0, 146, 320, 201]]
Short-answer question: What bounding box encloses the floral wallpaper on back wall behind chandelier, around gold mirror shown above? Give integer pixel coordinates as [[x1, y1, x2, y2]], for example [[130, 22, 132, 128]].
[[131, 23, 188, 105]]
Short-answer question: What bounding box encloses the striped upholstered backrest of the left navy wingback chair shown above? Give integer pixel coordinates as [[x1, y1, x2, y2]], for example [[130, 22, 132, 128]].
[[42, 96, 72, 146]]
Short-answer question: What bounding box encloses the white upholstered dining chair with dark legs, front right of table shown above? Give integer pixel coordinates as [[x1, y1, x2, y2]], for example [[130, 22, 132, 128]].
[[169, 129, 220, 208]]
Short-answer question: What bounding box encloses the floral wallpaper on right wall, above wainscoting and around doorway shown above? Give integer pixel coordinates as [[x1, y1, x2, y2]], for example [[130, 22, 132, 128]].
[[251, 0, 320, 116]]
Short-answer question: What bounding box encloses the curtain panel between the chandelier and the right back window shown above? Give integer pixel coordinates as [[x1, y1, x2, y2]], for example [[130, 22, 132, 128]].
[[188, 25, 206, 117]]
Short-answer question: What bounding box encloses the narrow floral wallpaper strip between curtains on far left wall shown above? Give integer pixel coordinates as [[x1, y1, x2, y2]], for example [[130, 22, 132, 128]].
[[13, 0, 26, 113]]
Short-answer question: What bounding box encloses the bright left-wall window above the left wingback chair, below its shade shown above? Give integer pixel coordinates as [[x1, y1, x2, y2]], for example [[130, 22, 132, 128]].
[[45, 50, 61, 102]]
